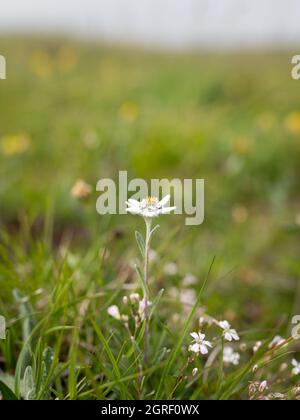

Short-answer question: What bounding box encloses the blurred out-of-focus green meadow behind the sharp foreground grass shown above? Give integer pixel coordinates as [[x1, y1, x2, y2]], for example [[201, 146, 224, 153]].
[[0, 37, 300, 327]]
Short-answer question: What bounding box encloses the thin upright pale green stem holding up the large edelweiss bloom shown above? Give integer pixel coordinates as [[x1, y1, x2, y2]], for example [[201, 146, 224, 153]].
[[144, 218, 152, 363]]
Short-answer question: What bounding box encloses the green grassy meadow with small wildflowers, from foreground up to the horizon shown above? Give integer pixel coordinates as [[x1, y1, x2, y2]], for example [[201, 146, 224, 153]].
[[0, 37, 300, 400]]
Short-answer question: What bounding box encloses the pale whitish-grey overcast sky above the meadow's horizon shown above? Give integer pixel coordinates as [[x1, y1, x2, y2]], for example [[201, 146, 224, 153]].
[[0, 0, 300, 48]]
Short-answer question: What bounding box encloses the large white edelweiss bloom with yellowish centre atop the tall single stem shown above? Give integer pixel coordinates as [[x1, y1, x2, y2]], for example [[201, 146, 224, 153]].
[[126, 195, 176, 219]]
